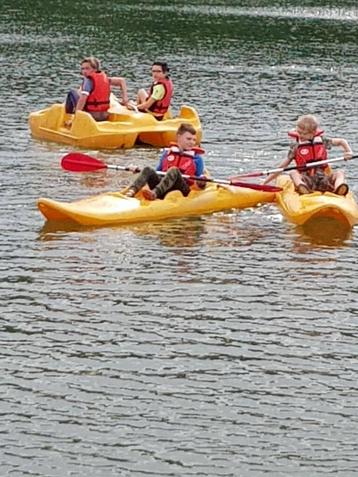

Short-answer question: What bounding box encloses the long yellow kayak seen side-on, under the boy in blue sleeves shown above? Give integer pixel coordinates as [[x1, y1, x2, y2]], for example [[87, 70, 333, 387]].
[[37, 184, 275, 226]]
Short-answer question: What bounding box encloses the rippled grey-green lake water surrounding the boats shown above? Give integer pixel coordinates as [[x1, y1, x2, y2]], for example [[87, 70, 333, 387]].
[[0, 0, 358, 477]]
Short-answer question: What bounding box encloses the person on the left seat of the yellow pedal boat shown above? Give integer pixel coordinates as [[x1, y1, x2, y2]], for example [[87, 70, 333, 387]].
[[65, 56, 128, 122]]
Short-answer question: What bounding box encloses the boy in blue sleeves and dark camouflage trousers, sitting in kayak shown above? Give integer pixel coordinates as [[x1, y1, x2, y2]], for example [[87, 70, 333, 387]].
[[126, 123, 206, 200]]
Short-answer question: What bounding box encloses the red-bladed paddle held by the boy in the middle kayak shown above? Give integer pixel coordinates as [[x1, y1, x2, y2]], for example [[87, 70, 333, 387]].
[[61, 152, 282, 192]]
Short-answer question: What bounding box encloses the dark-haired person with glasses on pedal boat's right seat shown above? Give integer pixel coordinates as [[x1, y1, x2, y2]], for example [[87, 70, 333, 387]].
[[137, 61, 174, 121]]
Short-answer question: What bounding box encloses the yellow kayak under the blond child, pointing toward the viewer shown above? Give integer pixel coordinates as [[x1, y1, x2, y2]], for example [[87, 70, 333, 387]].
[[276, 175, 358, 227]]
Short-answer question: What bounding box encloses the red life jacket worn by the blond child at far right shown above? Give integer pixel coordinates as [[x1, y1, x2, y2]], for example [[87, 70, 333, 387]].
[[288, 130, 328, 175]]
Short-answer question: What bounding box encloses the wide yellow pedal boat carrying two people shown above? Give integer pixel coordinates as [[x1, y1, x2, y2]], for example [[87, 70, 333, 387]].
[[29, 95, 202, 149]]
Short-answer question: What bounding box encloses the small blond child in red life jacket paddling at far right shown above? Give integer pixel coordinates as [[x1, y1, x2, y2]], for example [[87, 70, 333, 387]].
[[264, 114, 352, 195]]
